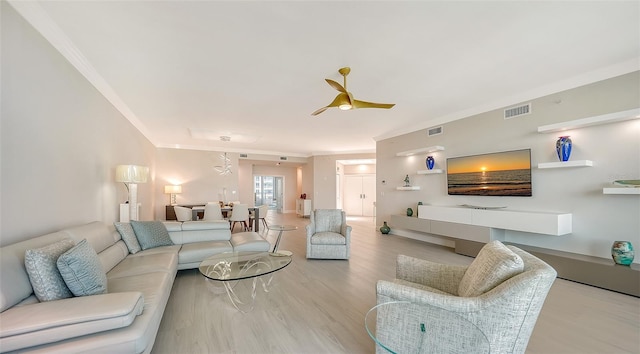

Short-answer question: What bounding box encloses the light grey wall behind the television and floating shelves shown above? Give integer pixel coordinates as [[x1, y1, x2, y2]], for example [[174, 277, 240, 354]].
[[377, 72, 640, 262]]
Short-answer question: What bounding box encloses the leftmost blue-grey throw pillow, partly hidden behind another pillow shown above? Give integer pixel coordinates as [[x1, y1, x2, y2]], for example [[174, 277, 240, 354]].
[[24, 238, 74, 302]]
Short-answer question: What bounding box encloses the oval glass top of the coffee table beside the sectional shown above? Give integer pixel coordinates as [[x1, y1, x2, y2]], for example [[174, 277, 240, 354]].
[[199, 252, 291, 281]]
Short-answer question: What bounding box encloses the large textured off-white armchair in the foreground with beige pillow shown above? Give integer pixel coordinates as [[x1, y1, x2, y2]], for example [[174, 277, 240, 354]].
[[375, 241, 556, 353]]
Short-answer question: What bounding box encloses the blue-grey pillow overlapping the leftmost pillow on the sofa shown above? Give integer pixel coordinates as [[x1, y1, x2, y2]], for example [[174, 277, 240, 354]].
[[57, 239, 107, 296]]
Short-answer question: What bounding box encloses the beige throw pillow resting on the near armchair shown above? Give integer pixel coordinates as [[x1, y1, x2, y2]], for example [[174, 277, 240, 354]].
[[458, 241, 524, 297]]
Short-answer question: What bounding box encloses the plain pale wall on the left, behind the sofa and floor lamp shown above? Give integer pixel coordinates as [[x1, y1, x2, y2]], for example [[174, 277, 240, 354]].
[[0, 1, 156, 245]]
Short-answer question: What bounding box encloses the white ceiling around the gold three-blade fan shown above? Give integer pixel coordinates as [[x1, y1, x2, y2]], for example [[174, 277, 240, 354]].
[[10, 0, 640, 157]]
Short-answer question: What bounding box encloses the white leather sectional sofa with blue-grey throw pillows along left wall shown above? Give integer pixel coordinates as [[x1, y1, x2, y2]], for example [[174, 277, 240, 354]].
[[0, 221, 269, 353]]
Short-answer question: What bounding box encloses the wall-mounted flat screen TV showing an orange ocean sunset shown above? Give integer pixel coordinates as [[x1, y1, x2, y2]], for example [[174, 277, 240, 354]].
[[447, 149, 531, 197]]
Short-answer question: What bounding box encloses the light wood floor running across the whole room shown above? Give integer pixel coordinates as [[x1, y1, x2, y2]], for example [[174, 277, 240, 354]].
[[152, 211, 640, 354]]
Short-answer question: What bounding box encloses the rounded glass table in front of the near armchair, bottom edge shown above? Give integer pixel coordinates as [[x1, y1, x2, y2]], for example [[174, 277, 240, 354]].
[[364, 301, 490, 354]]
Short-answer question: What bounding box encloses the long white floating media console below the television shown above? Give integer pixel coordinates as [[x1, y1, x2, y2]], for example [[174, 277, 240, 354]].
[[418, 205, 572, 236]]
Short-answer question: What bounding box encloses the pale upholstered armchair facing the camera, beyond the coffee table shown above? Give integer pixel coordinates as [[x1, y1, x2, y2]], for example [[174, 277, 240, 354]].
[[306, 209, 351, 259]]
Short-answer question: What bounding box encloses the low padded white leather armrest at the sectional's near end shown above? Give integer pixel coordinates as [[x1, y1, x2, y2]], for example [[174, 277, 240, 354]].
[[0, 292, 144, 352]]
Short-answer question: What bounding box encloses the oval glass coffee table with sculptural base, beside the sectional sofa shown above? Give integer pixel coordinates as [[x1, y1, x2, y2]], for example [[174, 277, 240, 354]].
[[199, 252, 291, 313]]
